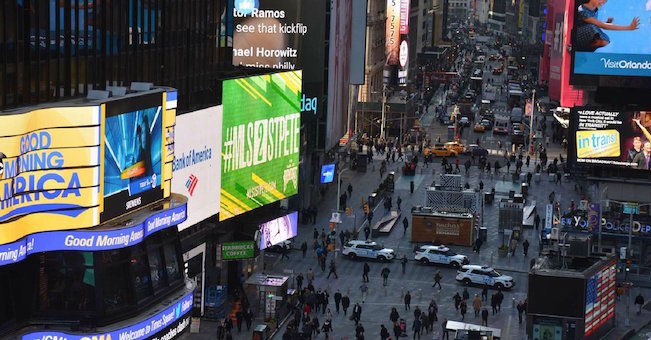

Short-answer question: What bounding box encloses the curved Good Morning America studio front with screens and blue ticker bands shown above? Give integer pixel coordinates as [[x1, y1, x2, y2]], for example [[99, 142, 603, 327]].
[[0, 84, 195, 340]]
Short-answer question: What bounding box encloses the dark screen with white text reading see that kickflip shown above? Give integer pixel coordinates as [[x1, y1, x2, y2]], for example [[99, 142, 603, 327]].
[[233, 0, 309, 70]]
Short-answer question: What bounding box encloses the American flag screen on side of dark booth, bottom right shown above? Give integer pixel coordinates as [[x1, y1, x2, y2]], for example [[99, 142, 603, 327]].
[[585, 261, 616, 337]]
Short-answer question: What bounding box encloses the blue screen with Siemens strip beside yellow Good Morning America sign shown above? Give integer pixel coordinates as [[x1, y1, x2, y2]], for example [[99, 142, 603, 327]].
[[102, 93, 163, 220]]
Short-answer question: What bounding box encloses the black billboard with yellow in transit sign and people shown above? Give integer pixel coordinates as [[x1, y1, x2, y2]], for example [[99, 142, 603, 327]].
[[568, 107, 651, 170]]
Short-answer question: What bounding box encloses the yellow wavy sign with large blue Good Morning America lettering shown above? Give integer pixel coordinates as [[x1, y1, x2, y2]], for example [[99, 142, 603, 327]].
[[0, 106, 101, 244]]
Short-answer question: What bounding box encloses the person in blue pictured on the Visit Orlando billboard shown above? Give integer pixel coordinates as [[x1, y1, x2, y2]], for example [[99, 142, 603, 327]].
[[574, 0, 640, 52]]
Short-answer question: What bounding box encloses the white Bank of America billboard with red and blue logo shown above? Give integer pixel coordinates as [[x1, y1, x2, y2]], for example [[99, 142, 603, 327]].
[[172, 106, 222, 231]]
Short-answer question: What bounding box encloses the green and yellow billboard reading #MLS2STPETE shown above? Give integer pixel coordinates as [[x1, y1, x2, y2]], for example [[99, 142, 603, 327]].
[[219, 71, 301, 220]]
